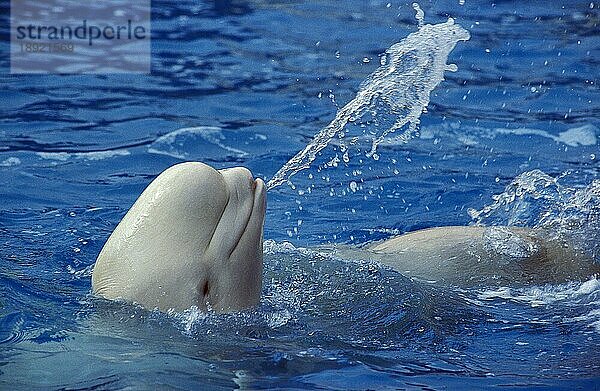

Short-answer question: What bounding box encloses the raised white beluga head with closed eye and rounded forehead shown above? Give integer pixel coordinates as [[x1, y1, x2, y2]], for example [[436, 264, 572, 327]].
[[92, 162, 266, 312]]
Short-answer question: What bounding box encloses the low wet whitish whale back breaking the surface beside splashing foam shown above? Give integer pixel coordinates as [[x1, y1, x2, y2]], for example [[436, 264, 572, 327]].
[[326, 226, 600, 287]]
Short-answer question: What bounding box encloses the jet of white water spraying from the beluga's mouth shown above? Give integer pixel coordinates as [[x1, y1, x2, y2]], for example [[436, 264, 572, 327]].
[[267, 3, 470, 189]]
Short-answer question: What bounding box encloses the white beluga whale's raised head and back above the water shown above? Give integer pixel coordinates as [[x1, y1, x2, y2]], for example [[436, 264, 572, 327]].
[[92, 163, 600, 312]]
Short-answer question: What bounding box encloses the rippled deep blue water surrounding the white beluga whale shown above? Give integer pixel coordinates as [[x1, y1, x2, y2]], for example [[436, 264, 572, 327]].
[[0, 0, 600, 390]]
